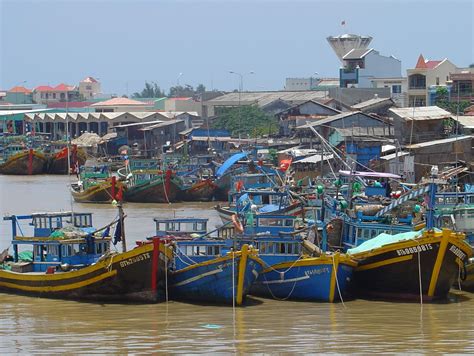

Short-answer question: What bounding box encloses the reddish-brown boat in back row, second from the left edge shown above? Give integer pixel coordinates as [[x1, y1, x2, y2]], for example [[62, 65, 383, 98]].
[[46, 145, 87, 174]]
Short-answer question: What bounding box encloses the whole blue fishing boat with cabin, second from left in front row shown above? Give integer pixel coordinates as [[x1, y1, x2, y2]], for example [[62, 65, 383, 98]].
[[155, 218, 263, 305]]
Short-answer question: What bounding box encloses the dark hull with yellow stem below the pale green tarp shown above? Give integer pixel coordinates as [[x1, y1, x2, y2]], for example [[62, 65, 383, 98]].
[[352, 230, 472, 300]]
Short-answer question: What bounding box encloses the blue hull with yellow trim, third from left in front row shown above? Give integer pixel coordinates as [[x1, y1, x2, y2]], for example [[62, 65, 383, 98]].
[[250, 254, 356, 303]]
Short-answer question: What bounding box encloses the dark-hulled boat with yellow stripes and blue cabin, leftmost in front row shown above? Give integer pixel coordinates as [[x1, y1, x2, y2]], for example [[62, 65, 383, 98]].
[[0, 212, 166, 303]]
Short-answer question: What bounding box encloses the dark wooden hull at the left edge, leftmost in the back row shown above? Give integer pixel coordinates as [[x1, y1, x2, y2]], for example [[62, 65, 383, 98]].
[[0, 150, 47, 175]]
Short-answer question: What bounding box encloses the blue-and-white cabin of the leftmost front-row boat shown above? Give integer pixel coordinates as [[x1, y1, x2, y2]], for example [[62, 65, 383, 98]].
[[4, 212, 110, 272]]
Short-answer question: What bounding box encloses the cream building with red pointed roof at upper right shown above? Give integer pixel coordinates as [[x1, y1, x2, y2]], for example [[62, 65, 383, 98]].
[[407, 54, 457, 106]]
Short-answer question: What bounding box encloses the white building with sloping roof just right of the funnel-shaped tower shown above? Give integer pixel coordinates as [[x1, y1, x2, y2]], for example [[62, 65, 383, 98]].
[[339, 48, 402, 88]]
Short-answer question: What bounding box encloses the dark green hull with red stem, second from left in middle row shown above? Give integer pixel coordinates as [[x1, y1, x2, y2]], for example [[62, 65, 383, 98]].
[[124, 179, 180, 203]]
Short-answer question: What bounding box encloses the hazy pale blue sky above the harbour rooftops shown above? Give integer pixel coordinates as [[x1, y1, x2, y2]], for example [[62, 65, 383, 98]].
[[0, 0, 474, 94]]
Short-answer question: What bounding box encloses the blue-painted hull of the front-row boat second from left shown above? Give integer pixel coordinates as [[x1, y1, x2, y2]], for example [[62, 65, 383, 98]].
[[169, 256, 263, 304]]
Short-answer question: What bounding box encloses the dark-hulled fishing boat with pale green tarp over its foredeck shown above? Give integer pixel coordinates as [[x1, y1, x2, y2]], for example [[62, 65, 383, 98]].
[[337, 167, 472, 300]]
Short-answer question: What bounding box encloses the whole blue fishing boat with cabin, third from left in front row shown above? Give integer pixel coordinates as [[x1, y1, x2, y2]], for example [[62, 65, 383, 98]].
[[235, 215, 356, 302]]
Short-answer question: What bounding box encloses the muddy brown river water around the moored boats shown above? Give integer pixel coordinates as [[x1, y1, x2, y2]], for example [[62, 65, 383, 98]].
[[0, 176, 474, 355]]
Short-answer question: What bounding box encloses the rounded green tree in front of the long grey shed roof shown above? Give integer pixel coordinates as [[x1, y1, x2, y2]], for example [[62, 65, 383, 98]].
[[212, 105, 278, 137]]
